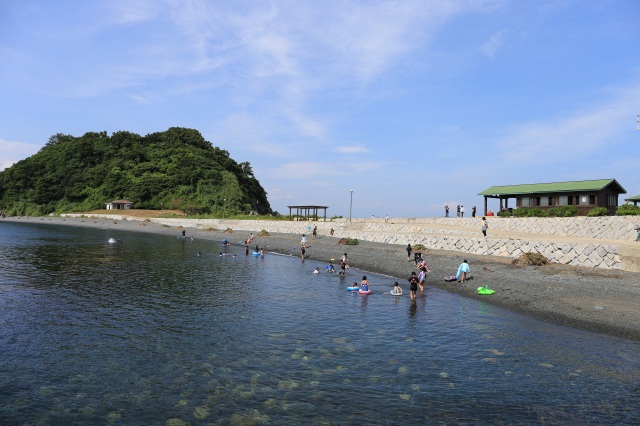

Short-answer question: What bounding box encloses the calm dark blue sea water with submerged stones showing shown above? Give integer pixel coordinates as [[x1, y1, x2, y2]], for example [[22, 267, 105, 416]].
[[0, 222, 640, 425]]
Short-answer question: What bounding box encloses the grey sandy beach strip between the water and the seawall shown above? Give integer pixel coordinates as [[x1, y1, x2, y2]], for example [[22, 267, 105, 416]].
[[3, 217, 640, 341]]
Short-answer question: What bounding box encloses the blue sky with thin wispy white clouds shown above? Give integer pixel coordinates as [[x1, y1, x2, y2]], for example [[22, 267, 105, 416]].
[[0, 0, 640, 217]]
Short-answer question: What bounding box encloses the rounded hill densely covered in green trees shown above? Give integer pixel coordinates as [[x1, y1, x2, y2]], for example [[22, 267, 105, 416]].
[[0, 127, 271, 216]]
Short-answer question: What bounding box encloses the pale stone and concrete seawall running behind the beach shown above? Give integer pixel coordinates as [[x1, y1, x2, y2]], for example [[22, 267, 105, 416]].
[[67, 214, 640, 272]]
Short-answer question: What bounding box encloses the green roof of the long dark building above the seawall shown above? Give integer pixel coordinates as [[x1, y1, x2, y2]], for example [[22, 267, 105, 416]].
[[478, 179, 627, 196]]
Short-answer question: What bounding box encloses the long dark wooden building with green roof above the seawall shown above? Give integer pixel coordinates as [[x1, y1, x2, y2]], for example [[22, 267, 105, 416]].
[[478, 179, 624, 215]]
